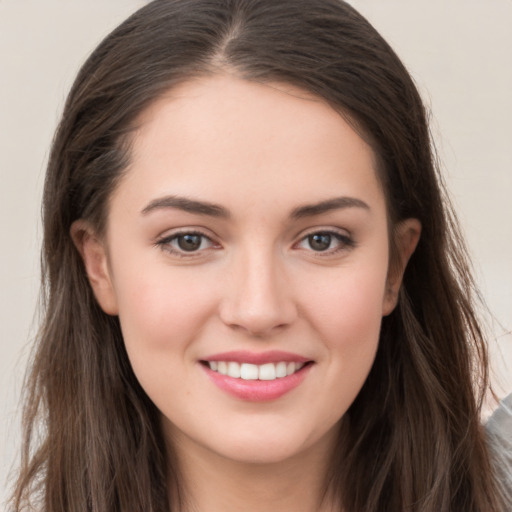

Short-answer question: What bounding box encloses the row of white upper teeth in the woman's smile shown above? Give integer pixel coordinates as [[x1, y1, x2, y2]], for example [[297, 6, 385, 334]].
[[208, 361, 304, 380]]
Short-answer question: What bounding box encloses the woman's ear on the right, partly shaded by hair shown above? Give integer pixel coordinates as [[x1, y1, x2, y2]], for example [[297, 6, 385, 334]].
[[382, 219, 421, 316]]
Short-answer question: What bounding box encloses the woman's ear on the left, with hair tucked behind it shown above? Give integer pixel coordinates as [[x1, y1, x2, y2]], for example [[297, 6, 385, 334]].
[[70, 220, 118, 315]]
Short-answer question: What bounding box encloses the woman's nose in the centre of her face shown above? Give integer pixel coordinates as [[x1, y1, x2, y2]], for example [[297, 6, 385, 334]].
[[220, 247, 297, 337]]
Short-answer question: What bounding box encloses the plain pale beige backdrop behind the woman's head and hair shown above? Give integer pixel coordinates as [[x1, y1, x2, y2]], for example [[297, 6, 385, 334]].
[[0, 0, 512, 509]]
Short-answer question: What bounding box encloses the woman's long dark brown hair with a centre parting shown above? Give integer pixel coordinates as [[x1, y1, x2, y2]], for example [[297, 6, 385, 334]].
[[13, 0, 506, 512]]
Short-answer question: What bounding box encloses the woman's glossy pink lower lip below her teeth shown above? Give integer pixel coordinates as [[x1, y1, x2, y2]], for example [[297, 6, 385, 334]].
[[201, 364, 313, 402]]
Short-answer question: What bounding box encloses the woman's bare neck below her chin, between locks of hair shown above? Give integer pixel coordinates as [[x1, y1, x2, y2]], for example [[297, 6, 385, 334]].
[[165, 424, 340, 512]]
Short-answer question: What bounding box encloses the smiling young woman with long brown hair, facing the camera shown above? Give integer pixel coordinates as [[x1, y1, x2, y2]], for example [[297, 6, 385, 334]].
[[10, 0, 510, 512]]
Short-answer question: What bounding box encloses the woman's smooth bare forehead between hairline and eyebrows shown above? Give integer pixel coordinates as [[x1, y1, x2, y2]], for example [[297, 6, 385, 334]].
[[112, 75, 383, 219]]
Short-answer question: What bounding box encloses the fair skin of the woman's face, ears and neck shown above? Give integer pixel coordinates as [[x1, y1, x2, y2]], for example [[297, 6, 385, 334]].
[[72, 75, 420, 512]]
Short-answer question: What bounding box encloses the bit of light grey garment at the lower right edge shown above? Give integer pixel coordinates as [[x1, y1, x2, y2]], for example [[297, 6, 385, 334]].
[[485, 394, 512, 512]]
